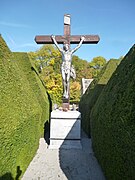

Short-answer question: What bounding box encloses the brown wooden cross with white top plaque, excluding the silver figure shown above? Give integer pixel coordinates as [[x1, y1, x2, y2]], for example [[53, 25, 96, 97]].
[[35, 14, 100, 108]]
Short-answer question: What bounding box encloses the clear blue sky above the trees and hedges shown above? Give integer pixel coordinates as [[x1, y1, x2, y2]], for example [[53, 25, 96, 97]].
[[0, 0, 135, 61]]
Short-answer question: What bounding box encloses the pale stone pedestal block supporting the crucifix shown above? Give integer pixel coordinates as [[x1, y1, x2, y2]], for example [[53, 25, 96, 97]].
[[49, 111, 81, 149]]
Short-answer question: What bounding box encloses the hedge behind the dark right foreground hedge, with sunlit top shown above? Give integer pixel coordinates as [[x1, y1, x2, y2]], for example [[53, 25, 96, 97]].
[[79, 59, 120, 136]]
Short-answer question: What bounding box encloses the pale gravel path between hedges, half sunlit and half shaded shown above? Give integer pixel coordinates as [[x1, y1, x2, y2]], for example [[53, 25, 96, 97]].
[[22, 133, 105, 180]]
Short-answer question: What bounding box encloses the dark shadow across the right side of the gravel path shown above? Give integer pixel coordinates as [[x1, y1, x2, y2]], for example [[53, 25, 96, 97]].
[[59, 131, 105, 180]]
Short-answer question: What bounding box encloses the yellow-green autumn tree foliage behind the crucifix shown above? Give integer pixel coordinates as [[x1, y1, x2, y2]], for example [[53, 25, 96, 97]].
[[29, 45, 106, 104]]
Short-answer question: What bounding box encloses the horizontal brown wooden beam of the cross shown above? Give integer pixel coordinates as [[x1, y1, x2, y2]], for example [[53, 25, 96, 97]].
[[35, 35, 100, 44]]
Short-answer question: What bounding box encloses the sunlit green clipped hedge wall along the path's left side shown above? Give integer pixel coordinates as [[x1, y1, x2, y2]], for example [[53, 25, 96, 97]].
[[0, 36, 49, 180]]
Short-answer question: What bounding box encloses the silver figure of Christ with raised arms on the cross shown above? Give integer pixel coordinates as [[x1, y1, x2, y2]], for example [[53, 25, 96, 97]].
[[51, 35, 85, 99]]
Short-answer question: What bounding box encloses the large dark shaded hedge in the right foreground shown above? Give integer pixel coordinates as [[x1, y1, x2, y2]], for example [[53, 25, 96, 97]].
[[91, 45, 135, 180]]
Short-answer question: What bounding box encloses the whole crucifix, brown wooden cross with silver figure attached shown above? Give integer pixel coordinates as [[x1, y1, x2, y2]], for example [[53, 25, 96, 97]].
[[35, 14, 100, 109]]
